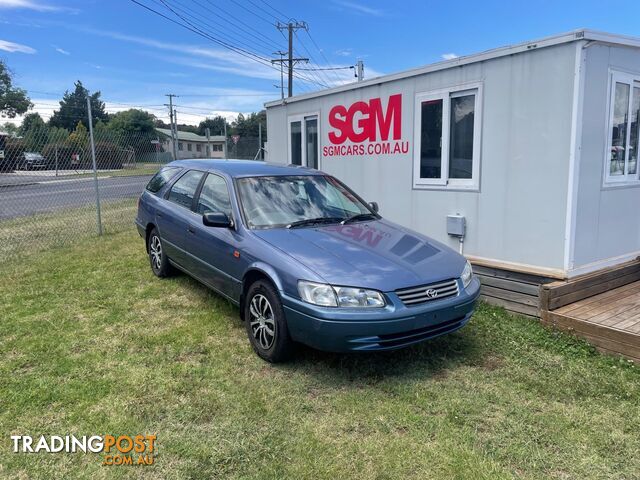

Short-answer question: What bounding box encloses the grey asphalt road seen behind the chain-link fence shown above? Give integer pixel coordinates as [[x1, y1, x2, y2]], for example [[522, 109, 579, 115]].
[[0, 175, 151, 220]]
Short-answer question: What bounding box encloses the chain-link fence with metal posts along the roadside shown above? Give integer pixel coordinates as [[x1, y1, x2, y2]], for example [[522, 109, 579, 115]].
[[0, 100, 260, 261]]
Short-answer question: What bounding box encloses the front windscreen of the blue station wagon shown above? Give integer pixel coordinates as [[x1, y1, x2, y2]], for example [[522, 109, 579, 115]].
[[237, 175, 372, 228]]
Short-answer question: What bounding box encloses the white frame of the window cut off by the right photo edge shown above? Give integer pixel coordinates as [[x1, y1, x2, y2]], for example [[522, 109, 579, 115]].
[[602, 70, 640, 188]]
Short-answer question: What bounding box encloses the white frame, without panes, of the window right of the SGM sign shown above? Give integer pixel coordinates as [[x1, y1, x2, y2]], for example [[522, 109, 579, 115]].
[[413, 82, 483, 191]]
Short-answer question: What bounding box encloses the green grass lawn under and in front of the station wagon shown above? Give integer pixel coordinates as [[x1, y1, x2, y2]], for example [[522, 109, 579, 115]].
[[0, 230, 640, 479]]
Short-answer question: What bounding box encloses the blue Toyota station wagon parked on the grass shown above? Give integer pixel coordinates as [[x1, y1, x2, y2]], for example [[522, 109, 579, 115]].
[[136, 160, 480, 362]]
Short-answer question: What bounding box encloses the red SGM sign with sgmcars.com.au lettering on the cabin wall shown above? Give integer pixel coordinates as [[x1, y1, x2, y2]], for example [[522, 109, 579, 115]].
[[322, 93, 409, 157]]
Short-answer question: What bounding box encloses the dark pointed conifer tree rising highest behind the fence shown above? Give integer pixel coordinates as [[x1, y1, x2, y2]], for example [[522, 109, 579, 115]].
[[49, 80, 109, 130]]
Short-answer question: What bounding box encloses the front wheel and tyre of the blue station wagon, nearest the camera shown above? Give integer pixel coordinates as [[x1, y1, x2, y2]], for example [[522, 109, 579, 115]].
[[243, 280, 295, 363]]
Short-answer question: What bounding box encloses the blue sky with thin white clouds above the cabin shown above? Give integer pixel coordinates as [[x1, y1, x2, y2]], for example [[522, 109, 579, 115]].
[[0, 0, 640, 124]]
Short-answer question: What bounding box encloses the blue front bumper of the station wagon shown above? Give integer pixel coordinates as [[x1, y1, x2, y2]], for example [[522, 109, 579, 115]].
[[282, 276, 480, 352]]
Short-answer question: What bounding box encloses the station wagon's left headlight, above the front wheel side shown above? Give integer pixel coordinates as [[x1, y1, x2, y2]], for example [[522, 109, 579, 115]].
[[298, 280, 385, 308]]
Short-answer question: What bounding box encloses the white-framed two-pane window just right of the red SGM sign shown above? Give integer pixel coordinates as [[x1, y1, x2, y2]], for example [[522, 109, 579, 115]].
[[413, 85, 481, 189]]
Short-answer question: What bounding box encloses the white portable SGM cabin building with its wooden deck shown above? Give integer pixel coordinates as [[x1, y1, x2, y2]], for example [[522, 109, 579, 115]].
[[266, 30, 640, 361]]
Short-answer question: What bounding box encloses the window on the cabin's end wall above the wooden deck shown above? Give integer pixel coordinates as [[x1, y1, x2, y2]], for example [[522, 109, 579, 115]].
[[605, 72, 640, 184]]
